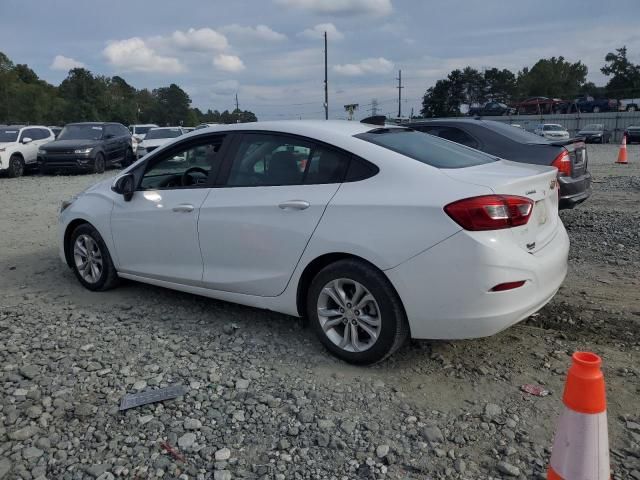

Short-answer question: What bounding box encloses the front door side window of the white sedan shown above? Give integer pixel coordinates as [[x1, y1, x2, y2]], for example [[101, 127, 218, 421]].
[[139, 136, 224, 190]]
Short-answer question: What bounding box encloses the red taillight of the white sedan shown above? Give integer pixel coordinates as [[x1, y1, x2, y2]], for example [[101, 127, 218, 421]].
[[444, 195, 533, 231]]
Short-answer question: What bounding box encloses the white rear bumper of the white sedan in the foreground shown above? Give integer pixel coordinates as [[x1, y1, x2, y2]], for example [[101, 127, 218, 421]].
[[385, 220, 569, 339]]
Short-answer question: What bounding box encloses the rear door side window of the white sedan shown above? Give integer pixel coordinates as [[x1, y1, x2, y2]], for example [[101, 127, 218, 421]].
[[227, 133, 349, 187]]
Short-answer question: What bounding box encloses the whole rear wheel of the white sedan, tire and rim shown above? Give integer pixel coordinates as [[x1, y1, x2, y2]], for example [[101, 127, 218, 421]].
[[307, 259, 409, 365]]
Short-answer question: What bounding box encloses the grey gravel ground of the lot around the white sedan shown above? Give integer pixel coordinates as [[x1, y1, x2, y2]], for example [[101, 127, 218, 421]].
[[0, 145, 640, 480]]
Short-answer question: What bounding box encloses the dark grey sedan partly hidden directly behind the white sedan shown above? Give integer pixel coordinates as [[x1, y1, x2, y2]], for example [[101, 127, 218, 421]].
[[409, 118, 591, 208]]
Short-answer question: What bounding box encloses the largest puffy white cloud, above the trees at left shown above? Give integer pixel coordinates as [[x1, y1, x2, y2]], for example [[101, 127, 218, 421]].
[[102, 37, 185, 73]]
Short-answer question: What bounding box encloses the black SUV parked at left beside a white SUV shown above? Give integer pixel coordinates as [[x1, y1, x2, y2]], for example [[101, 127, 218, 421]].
[[38, 122, 134, 173]]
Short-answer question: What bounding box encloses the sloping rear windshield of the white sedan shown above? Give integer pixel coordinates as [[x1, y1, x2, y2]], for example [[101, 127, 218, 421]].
[[355, 128, 497, 168]]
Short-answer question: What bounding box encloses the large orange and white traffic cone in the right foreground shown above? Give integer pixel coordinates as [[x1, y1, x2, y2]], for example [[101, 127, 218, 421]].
[[547, 352, 610, 480]]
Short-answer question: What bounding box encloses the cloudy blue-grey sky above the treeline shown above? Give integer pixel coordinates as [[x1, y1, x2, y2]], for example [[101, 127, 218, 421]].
[[0, 0, 640, 120]]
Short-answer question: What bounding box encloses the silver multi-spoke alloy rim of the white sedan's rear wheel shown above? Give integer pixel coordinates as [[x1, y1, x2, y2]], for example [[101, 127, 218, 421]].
[[317, 278, 382, 352]]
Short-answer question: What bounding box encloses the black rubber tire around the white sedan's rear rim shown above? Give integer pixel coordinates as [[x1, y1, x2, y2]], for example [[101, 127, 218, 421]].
[[307, 259, 409, 365]]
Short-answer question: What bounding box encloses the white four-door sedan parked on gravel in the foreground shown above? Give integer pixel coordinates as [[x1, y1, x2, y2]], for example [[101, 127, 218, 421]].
[[59, 121, 569, 364]]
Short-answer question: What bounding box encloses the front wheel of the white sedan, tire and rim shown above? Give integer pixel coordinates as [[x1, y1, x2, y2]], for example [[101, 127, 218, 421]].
[[68, 223, 118, 291]]
